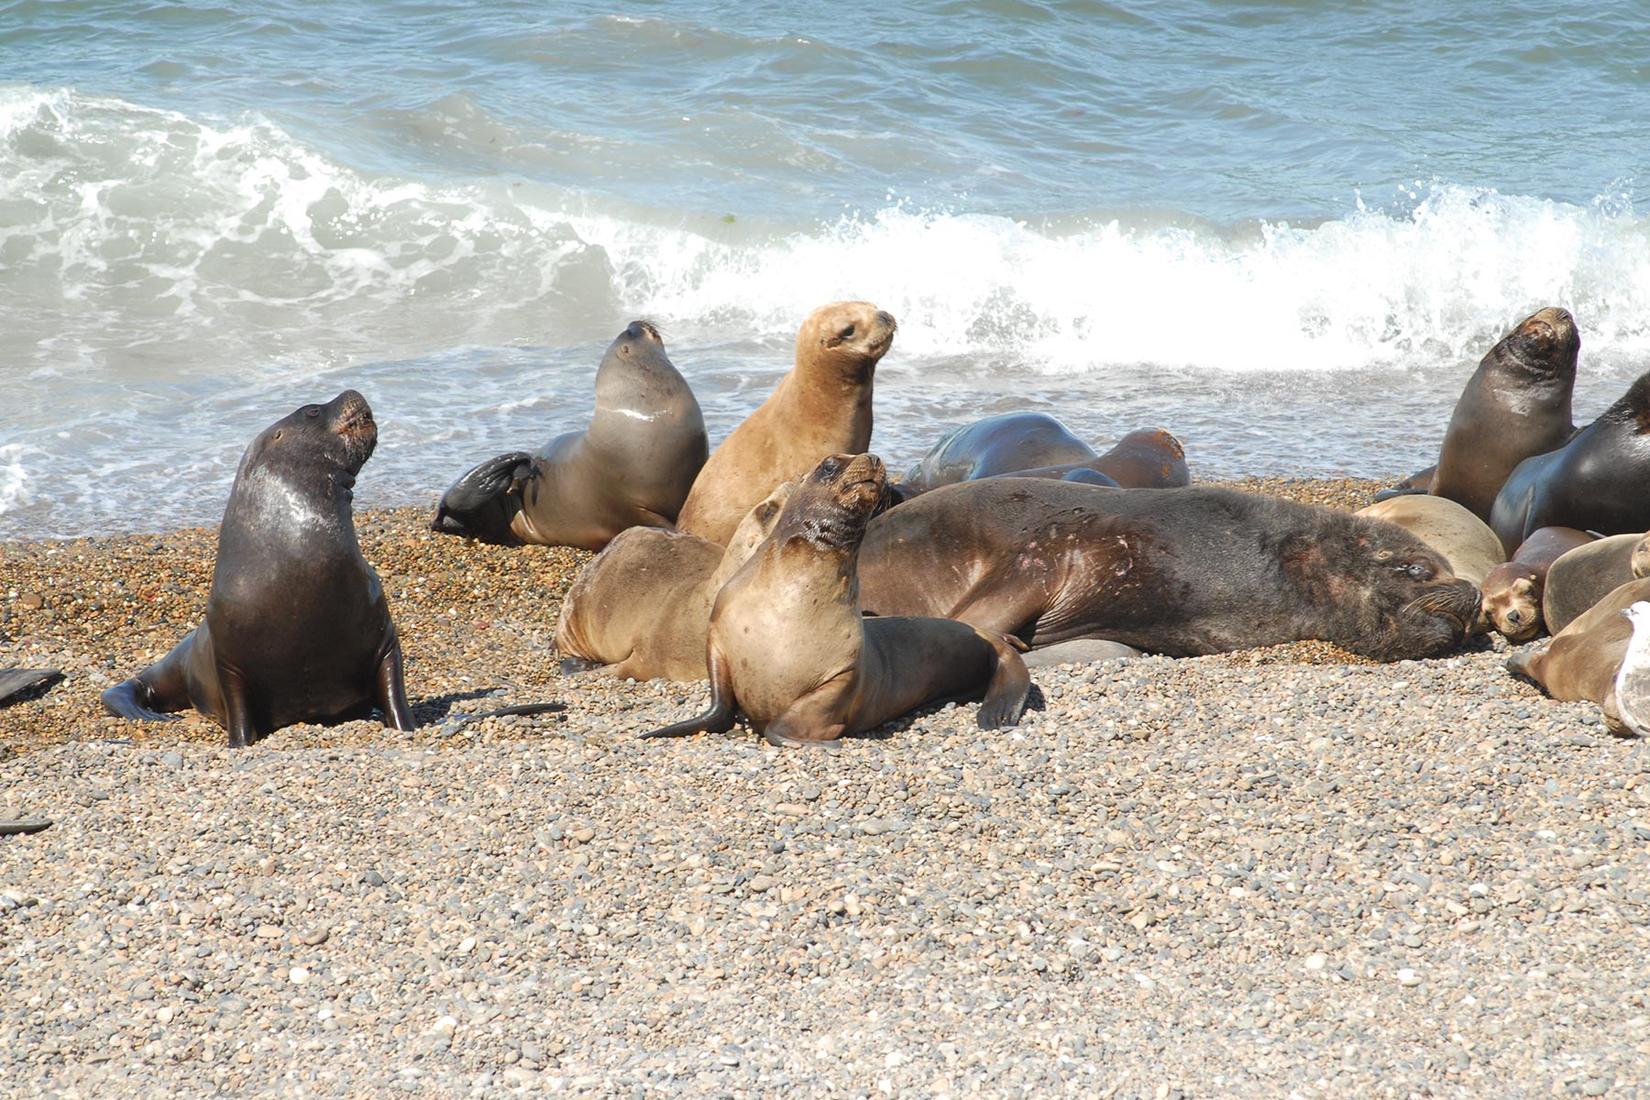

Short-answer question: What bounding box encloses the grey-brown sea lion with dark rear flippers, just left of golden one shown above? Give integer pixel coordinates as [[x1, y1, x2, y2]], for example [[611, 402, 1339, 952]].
[[431, 322, 706, 551]]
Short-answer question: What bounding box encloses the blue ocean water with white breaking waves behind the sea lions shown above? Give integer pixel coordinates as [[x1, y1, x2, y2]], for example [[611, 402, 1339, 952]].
[[0, 0, 1650, 538]]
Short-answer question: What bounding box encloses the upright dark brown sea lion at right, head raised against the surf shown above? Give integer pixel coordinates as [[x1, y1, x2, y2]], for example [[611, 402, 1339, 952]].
[[1432, 307, 1582, 524]]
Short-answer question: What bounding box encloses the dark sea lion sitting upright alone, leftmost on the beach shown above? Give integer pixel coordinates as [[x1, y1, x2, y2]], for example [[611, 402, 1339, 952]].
[[102, 389, 413, 747]]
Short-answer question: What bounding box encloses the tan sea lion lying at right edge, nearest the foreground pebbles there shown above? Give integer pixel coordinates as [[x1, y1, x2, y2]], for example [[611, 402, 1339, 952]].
[[1506, 577, 1650, 732]]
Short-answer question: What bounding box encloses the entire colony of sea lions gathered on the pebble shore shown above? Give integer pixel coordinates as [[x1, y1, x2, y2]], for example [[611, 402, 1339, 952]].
[[104, 302, 1650, 745]]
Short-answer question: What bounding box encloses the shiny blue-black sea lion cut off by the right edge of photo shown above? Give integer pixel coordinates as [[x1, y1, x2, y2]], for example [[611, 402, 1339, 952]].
[[1490, 373, 1650, 546]]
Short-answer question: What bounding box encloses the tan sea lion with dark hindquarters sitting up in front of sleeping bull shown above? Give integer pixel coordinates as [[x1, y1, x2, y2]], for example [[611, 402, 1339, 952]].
[[644, 455, 1031, 745]]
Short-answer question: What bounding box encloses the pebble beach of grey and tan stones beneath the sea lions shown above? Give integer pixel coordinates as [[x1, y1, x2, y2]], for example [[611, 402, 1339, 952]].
[[0, 480, 1650, 1097]]
